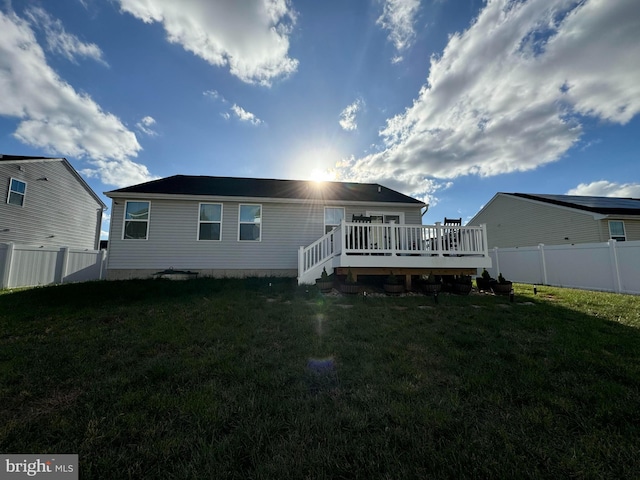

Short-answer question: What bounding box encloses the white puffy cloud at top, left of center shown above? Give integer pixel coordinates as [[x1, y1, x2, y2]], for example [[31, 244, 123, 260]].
[[119, 0, 298, 86]]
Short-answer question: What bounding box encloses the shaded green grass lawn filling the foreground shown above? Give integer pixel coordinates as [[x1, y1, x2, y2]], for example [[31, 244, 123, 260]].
[[0, 279, 640, 479]]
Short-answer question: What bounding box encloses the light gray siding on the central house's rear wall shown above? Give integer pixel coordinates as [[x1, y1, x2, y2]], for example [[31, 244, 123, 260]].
[[108, 198, 420, 273]]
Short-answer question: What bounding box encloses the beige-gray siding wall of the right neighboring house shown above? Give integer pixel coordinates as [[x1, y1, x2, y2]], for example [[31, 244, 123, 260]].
[[470, 195, 609, 248]]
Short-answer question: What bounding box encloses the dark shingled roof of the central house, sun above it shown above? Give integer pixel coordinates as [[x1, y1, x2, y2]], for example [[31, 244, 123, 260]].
[[106, 175, 424, 206]]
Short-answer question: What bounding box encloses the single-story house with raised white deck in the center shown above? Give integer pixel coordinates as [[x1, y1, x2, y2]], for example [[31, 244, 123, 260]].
[[105, 175, 490, 283]]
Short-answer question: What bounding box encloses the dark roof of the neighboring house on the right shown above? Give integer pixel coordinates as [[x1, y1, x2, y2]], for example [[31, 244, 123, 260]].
[[508, 193, 640, 215]]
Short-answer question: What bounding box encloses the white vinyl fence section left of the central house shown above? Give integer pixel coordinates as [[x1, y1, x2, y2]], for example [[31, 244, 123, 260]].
[[0, 243, 107, 289]]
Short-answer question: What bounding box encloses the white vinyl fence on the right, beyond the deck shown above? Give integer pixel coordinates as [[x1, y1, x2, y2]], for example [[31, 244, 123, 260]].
[[489, 240, 640, 295]]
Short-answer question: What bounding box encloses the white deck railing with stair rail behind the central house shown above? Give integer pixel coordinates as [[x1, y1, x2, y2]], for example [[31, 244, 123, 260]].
[[298, 221, 489, 284]]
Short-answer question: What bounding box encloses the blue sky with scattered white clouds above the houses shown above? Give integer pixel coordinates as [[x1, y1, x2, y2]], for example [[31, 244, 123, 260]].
[[0, 0, 640, 238]]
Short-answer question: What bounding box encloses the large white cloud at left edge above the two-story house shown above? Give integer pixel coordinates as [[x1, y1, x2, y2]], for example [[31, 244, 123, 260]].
[[0, 11, 151, 186]]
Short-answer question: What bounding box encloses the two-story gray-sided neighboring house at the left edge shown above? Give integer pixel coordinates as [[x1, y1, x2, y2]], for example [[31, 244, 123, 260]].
[[0, 155, 106, 250]]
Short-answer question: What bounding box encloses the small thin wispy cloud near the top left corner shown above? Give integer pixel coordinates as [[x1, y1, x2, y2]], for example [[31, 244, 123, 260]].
[[25, 7, 107, 65]]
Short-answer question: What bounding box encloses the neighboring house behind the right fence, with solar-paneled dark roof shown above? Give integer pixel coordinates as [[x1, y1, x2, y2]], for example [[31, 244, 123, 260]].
[[467, 192, 640, 248]]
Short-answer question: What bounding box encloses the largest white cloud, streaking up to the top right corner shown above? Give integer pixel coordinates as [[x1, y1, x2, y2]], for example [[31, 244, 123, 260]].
[[342, 0, 640, 199]]
